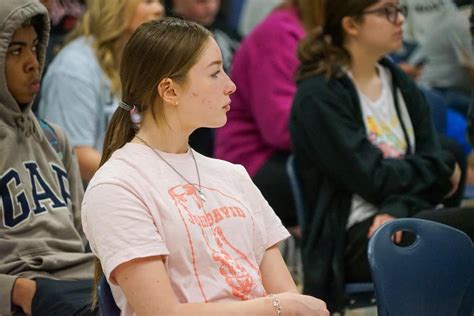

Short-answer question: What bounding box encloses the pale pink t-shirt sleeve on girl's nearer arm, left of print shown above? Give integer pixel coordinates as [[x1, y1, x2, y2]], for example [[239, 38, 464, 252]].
[[82, 184, 169, 283]]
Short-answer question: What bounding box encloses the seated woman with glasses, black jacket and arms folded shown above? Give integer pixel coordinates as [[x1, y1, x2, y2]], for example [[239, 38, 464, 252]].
[[290, 0, 474, 312]]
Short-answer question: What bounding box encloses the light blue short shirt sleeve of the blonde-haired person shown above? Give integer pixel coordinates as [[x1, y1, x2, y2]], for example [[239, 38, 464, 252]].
[[39, 69, 100, 147]]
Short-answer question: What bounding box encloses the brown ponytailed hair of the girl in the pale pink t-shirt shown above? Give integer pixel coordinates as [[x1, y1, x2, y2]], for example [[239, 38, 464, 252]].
[[93, 18, 212, 305]]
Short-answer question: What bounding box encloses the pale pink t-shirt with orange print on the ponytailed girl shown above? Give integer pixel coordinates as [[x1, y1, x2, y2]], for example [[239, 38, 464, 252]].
[[82, 143, 289, 315]]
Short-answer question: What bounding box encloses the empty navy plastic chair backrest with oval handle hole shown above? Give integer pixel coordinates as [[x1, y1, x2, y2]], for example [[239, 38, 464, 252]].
[[368, 218, 474, 316]]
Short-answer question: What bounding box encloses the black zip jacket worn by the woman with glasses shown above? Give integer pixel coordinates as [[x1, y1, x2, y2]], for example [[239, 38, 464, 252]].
[[290, 60, 455, 311]]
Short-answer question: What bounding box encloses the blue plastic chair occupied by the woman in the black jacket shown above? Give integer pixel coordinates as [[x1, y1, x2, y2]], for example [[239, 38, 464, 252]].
[[286, 155, 376, 309]]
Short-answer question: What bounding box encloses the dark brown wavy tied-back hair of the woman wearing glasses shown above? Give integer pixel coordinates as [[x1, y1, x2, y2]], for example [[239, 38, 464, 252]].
[[296, 0, 379, 80]]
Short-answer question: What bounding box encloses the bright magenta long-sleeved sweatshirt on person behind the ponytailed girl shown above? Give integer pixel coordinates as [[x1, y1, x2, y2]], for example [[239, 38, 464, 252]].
[[214, 8, 305, 176]]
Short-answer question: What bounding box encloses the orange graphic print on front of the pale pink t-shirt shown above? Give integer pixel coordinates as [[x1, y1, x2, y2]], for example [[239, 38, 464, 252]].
[[168, 184, 266, 302]]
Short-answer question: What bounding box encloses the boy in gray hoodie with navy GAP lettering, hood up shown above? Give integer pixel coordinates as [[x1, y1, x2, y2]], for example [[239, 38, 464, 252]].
[[0, 0, 93, 315]]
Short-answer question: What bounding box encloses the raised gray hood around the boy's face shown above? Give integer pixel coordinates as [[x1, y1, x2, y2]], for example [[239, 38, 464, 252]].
[[0, 0, 49, 136]]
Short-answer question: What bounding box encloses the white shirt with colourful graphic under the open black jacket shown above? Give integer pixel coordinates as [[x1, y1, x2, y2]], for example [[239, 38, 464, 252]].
[[346, 65, 415, 229]]
